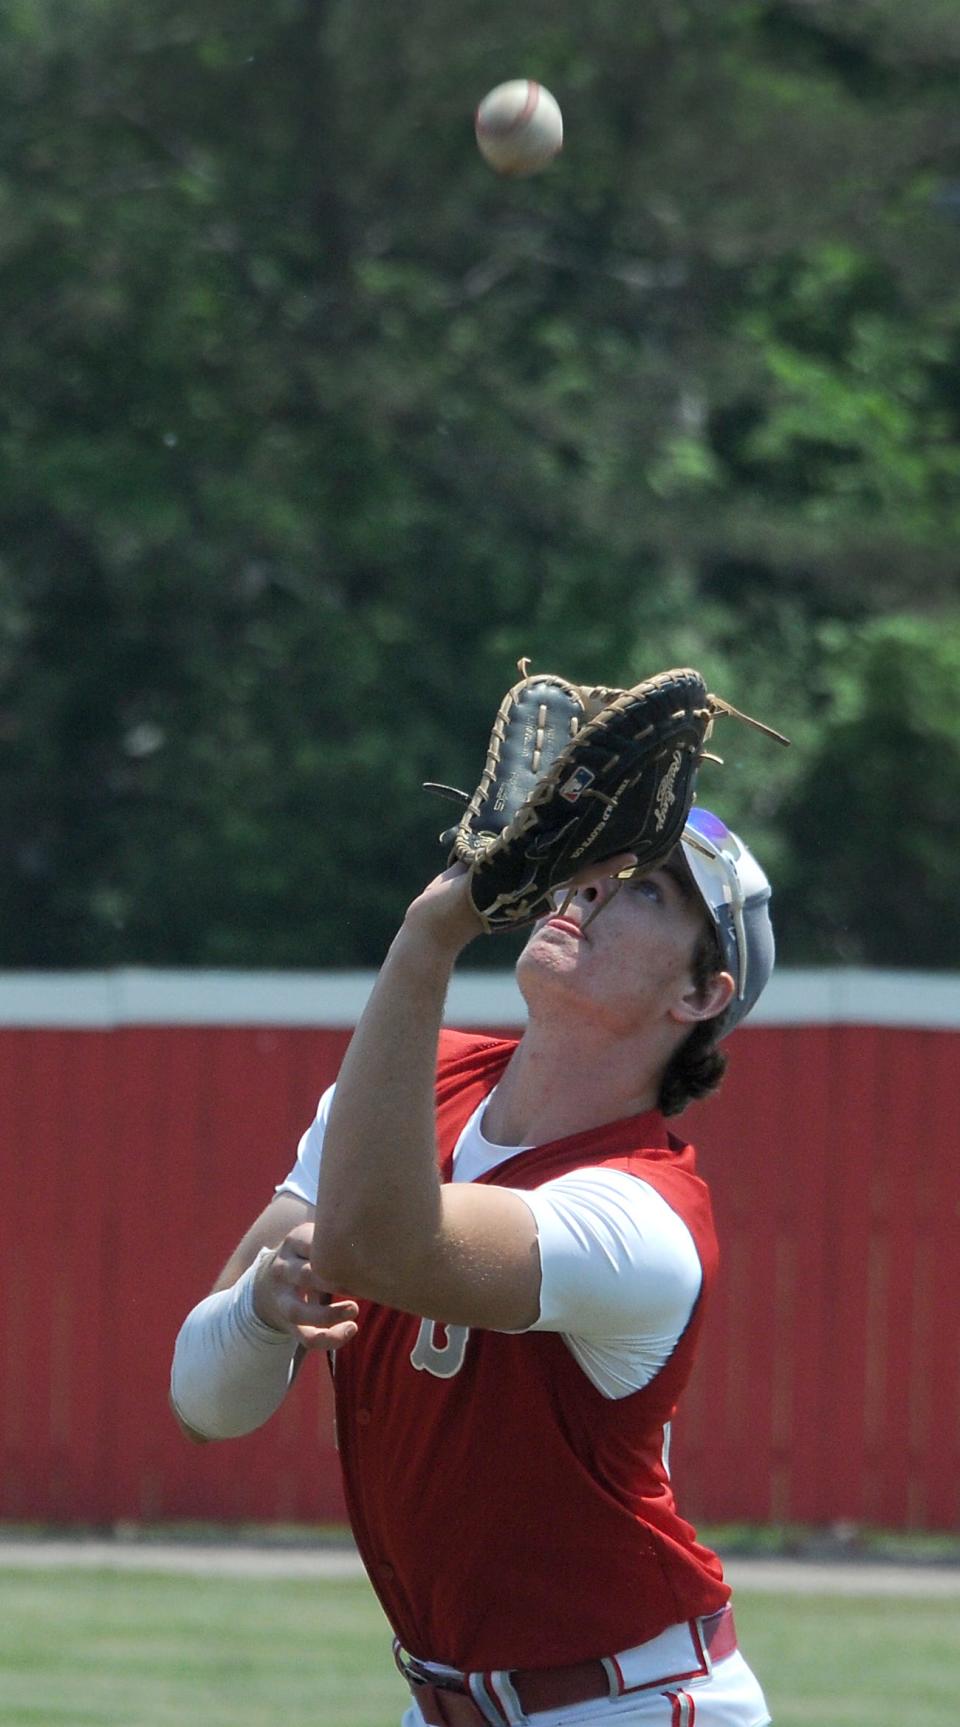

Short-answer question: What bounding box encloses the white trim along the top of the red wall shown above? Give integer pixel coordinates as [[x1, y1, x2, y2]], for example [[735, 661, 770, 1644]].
[[0, 967, 960, 1031]]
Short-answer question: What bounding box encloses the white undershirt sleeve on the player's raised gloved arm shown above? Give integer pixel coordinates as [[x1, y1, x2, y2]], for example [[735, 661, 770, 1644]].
[[511, 1167, 703, 1397]]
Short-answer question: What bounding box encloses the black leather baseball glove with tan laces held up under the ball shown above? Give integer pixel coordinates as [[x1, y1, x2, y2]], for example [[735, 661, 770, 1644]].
[[428, 660, 787, 934]]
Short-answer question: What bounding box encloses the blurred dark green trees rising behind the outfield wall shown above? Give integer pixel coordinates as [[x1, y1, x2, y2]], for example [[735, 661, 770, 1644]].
[[0, 0, 960, 967]]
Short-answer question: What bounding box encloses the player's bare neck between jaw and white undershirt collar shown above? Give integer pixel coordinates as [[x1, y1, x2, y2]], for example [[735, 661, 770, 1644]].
[[483, 1024, 660, 1145]]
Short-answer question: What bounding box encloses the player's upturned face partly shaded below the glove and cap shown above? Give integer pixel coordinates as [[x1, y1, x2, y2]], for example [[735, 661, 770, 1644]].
[[516, 858, 706, 1033]]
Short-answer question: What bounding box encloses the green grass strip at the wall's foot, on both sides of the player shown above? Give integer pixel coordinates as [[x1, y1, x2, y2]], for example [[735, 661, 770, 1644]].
[[0, 1559, 960, 1727]]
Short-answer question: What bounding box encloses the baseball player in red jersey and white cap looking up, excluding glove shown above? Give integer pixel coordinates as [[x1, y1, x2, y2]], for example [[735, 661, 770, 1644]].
[[171, 807, 774, 1727]]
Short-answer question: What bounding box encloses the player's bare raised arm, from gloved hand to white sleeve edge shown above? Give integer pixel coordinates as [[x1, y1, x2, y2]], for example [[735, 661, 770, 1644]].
[[311, 865, 539, 1328]]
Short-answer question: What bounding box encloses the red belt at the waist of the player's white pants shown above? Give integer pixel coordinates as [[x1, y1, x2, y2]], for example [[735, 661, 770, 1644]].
[[394, 1606, 737, 1727]]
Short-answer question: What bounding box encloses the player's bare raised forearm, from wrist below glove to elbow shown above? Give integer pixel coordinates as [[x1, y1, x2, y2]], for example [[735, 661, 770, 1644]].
[[311, 926, 463, 1306]]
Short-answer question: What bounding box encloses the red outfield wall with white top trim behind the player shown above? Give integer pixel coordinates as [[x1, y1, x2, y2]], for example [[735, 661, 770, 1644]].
[[0, 972, 960, 1528]]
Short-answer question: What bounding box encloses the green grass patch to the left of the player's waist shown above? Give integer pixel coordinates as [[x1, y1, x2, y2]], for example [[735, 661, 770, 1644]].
[[0, 1570, 404, 1727]]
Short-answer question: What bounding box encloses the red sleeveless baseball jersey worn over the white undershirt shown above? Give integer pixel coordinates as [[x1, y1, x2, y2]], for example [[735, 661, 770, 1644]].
[[333, 1033, 730, 1672]]
